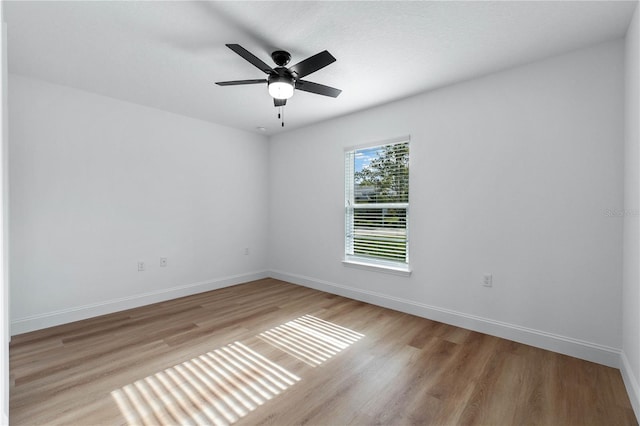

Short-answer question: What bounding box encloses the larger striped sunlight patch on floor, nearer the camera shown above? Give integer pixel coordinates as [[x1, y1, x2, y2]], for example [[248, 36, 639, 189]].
[[111, 342, 300, 425]]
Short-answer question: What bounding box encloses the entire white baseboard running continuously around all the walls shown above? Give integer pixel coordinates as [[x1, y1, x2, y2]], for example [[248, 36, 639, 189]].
[[11, 270, 624, 372]]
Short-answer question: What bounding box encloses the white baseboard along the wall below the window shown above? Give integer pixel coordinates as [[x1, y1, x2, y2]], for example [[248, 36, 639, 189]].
[[270, 270, 620, 368]]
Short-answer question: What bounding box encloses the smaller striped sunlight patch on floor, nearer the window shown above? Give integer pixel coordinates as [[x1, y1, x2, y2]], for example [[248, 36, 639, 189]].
[[258, 315, 364, 367]]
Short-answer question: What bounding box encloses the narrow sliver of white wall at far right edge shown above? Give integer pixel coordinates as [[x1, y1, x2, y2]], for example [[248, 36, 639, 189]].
[[621, 1, 640, 418]]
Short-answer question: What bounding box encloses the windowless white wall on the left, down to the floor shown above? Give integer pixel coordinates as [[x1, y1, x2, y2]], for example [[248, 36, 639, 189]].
[[9, 74, 268, 334]]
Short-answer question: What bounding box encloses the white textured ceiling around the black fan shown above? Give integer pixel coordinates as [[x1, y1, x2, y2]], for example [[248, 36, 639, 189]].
[[5, 1, 637, 134]]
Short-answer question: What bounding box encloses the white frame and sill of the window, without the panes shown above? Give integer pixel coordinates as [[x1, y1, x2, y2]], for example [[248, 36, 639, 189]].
[[342, 136, 411, 276]]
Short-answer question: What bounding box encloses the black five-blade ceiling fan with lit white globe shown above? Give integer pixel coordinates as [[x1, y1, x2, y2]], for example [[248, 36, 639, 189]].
[[216, 44, 342, 109]]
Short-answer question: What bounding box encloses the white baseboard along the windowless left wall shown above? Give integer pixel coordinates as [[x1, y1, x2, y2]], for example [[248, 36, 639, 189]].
[[11, 271, 269, 335]]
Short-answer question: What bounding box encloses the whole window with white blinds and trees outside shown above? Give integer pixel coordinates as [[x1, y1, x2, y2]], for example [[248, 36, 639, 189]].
[[344, 137, 409, 273]]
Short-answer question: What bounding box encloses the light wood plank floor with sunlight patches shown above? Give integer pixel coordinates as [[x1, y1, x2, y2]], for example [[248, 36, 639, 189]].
[[10, 279, 637, 425]]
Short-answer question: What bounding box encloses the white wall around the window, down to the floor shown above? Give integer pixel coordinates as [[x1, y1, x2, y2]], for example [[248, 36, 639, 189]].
[[269, 40, 624, 366]]
